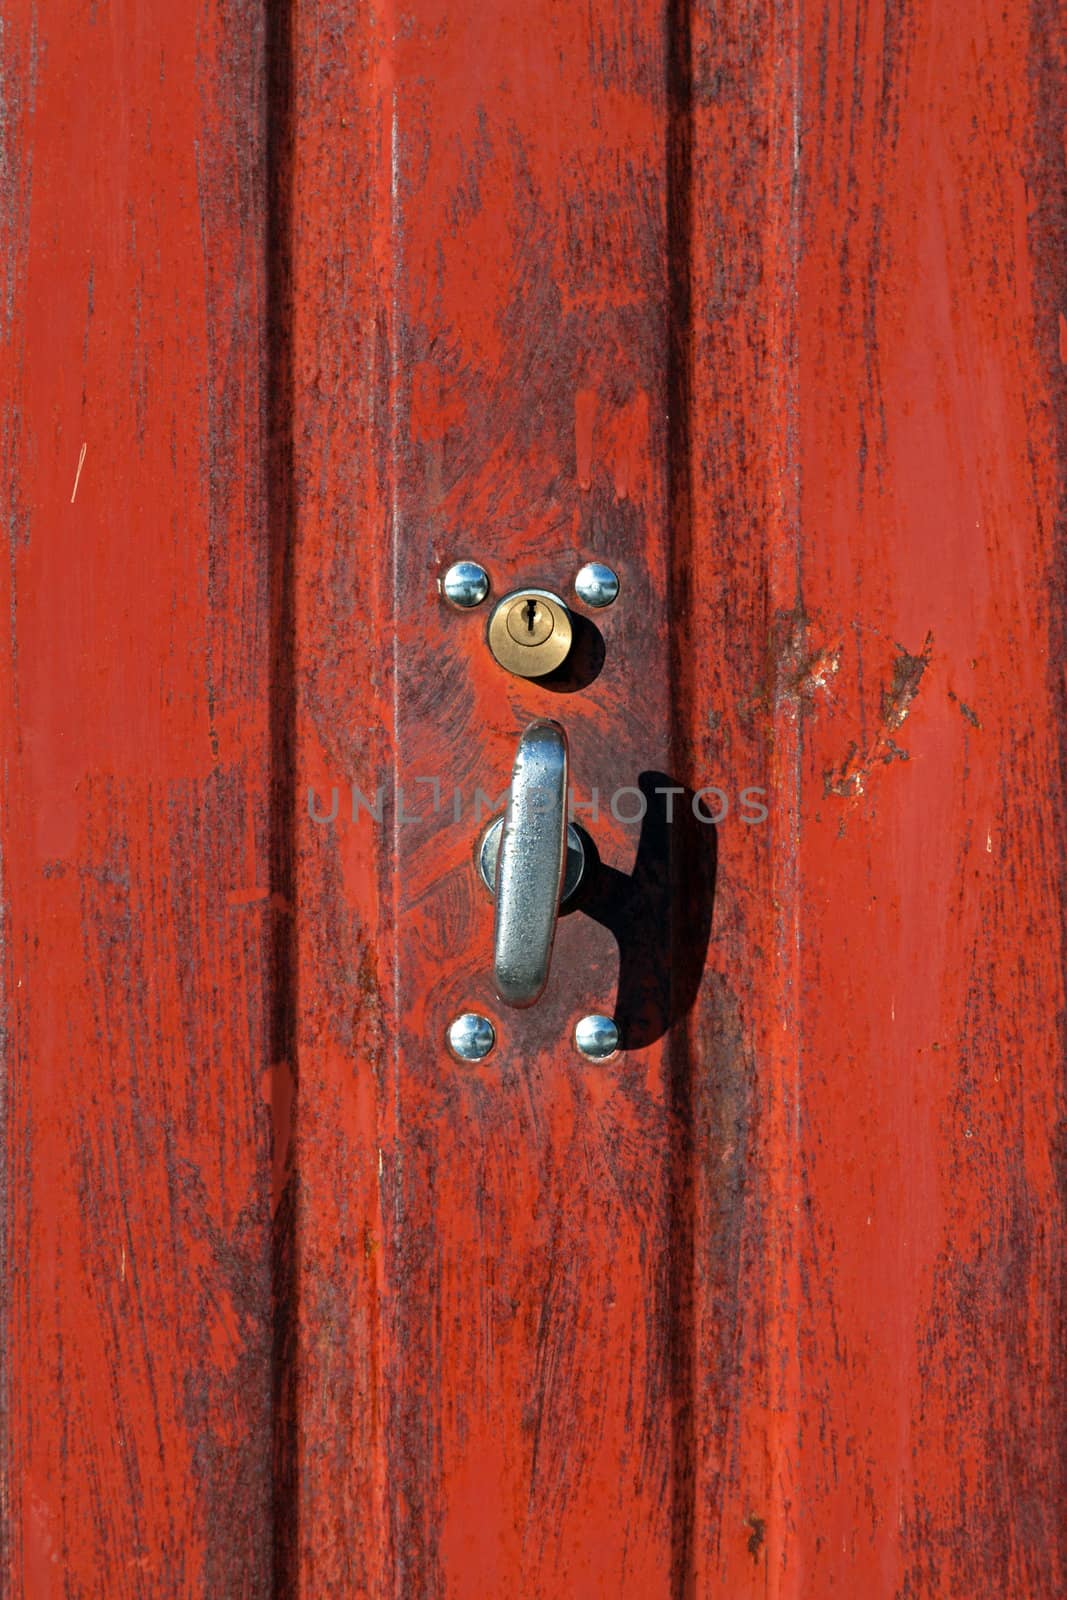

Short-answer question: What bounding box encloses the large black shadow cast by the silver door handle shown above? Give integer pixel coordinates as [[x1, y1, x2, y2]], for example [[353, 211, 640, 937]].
[[574, 771, 718, 1050]]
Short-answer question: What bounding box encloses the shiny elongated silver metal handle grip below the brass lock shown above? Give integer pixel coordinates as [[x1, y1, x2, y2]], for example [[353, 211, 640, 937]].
[[493, 720, 568, 1006]]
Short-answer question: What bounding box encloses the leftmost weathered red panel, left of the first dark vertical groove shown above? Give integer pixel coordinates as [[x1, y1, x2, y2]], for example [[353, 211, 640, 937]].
[[0, 0, 272, 1600]]
